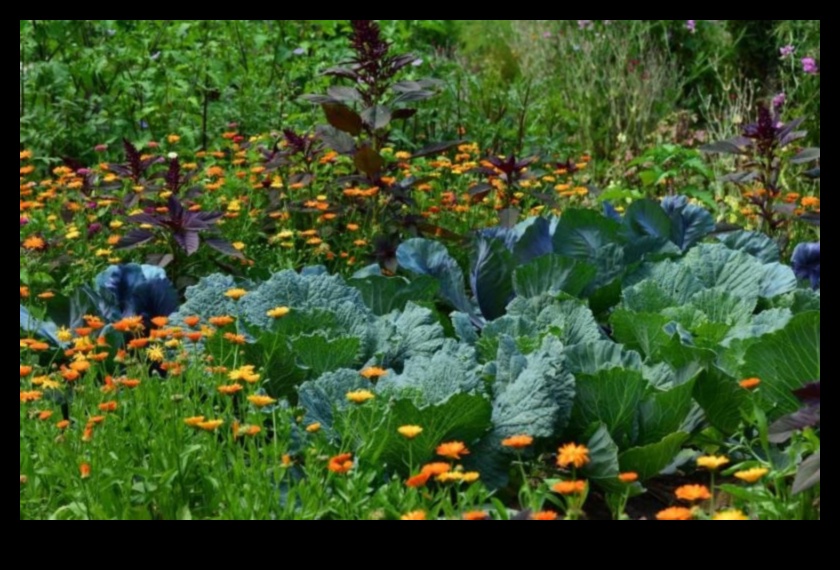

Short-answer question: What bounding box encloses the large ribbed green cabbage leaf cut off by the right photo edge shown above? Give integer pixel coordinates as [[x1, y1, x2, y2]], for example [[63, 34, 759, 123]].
[[742, 313, 820, 415]]
